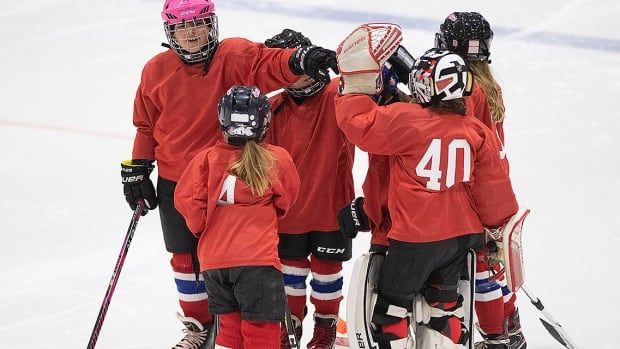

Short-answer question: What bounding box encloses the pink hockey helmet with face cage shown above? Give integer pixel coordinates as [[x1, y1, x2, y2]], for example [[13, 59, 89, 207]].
[[161, 0, 218, 64]]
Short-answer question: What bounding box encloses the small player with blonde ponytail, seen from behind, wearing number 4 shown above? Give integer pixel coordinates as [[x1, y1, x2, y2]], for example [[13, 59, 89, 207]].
[[174, 86, 299, 349]]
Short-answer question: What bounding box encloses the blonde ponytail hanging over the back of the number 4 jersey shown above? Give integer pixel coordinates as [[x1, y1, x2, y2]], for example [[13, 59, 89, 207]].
[[230, 140, 275, 196]]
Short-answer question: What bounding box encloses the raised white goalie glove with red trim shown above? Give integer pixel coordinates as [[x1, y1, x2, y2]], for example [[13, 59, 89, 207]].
[[336, 23, 403, 95]]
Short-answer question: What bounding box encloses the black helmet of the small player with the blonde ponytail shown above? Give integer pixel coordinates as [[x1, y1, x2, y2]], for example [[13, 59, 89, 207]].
[[217, 86, 271, 145]]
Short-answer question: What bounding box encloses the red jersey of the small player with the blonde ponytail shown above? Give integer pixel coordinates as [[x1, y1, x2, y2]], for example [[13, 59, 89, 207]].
[[174, 141, 299, 271]]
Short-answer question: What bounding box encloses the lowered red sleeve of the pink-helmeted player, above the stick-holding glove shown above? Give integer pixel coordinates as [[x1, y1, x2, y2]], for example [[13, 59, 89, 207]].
[[132, 67, 160, 160]]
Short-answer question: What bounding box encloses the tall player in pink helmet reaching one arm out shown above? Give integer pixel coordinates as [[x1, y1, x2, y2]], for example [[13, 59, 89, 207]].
[[122, 0, 336, 349]]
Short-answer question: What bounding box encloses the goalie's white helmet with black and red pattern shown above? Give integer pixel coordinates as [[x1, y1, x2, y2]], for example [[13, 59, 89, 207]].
[[409, 48, 473, 106]]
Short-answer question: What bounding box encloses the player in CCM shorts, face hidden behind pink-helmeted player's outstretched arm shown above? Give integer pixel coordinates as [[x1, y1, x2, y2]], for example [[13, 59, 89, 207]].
[[265, 29, 355, 349]]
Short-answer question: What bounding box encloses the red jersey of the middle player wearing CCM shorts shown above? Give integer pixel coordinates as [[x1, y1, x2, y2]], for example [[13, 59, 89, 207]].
[[267, 79, 355, 234]]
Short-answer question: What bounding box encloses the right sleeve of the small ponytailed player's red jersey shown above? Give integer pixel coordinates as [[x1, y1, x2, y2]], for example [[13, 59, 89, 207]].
[[270, 146, 301, 219]]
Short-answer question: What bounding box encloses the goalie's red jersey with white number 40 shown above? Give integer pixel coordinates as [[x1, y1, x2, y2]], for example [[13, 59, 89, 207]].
[[336, 94, 517, 242]]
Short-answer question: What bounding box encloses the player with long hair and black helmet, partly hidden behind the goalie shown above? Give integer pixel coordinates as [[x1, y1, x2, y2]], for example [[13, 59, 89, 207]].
[[435, 12, 526, 349]]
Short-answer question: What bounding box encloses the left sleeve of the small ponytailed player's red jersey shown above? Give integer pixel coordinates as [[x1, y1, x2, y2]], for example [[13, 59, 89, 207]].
[[174, 151, 209, 237]]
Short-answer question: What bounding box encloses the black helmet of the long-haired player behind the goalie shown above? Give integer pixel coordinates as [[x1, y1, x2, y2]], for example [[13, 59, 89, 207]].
[[435, 12, 493, 61]]
